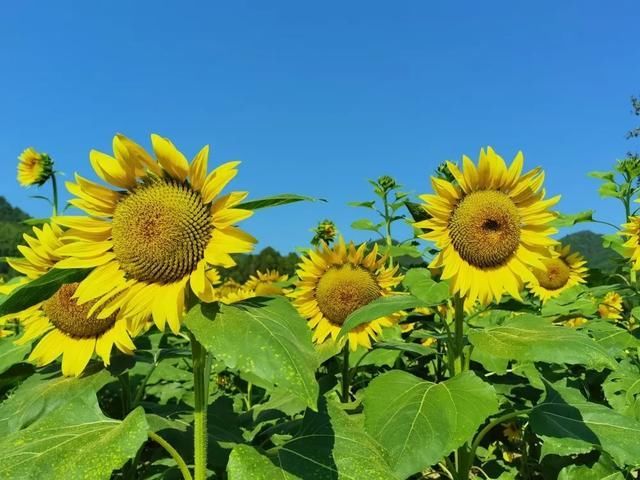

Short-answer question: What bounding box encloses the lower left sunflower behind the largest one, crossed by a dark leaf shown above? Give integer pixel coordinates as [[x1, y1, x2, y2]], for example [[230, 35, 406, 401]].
[[5, 224, 135, 376]]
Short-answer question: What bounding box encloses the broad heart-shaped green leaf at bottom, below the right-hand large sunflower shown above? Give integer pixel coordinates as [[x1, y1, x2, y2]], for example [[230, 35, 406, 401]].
[[364, 370, 498, 478]]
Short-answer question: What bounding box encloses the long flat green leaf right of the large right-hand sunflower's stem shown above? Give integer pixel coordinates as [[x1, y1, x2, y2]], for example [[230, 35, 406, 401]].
[[469, 314, 616, 369]]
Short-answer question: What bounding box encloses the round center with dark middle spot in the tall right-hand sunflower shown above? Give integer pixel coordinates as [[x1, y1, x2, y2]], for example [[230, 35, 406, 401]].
[[449, 190, 520, 268]]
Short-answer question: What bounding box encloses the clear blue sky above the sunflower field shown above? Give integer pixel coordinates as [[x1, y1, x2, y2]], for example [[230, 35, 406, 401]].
[[0, 0, 640, 251]]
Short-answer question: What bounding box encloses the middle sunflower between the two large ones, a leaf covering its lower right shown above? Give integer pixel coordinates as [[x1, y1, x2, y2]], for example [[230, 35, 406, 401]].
[[290, 238, 402, 350]]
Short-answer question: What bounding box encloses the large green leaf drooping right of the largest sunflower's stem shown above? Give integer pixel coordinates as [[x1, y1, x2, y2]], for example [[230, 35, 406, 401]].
[[185, 297, 319, 409]]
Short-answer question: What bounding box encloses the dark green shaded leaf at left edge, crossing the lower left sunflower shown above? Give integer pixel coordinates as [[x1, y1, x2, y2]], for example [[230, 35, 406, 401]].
[[0, 269, 90, 317]]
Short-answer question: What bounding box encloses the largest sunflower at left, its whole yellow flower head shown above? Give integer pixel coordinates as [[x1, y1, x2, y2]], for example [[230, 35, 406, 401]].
[[55, 135, 256, 333]]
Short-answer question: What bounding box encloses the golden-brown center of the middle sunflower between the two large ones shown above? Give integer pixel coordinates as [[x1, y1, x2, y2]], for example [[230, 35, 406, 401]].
[[316, 265, 380, 325]]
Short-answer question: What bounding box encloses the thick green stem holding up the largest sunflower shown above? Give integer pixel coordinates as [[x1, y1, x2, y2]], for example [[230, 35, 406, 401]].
[[190, 334, 211, 480]]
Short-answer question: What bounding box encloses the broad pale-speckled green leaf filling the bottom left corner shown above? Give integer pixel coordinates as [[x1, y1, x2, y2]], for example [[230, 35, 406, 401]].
[[0, 375, 148, 480]]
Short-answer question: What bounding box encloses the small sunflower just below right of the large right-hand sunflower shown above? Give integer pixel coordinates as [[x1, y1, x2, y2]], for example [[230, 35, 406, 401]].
[[529, 245, 589, 302]]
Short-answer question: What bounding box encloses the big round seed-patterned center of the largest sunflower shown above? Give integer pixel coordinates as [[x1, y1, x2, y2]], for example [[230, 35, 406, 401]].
[[113, 180, 212, 283]]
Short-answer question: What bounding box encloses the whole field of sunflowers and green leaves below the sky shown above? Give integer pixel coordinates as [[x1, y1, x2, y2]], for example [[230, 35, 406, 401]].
[[0, 131, 640, 480]]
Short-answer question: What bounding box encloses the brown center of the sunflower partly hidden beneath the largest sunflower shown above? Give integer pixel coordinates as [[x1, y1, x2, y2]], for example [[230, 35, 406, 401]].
[[42, 283, 116, 338]]
